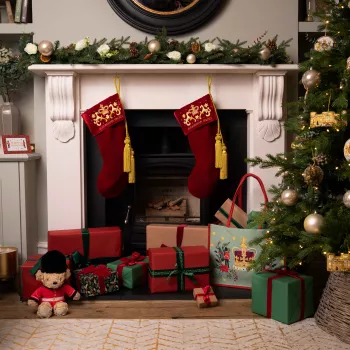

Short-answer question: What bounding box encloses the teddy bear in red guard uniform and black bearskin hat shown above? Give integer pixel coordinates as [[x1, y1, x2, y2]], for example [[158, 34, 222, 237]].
[[28, 250, 80, 318]]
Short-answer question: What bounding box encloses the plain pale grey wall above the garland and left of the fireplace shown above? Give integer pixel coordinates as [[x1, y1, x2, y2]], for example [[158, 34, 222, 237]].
[[26, 0, 298, 241]]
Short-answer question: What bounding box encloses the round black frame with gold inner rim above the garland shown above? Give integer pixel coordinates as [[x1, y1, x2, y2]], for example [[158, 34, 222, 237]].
[[107, 0, 223, 35]]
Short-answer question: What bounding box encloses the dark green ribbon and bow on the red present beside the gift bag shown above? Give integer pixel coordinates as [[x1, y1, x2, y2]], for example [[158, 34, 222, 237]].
[[148, 247, 210, 292]]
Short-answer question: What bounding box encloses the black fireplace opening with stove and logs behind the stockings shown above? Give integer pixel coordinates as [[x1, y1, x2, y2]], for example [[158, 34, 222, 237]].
[[85, 110, 247, 254]]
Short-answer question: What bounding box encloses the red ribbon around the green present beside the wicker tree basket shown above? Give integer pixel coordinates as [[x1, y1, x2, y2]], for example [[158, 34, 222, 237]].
[[263, 270, 305, 321]]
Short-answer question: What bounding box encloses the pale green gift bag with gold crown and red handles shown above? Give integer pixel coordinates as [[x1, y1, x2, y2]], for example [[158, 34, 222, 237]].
[[209, 174, 268, 289]]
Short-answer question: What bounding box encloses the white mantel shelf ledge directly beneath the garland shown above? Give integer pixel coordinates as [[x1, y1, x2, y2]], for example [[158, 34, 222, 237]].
[[29, 64, 299, 76]]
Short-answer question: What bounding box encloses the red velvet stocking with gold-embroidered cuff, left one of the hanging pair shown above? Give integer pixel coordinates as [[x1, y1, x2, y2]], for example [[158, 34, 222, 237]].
[[82, 94, 128, 198]]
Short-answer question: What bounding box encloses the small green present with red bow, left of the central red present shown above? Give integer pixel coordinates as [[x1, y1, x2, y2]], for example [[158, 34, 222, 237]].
[[107, 252, 148, 289]]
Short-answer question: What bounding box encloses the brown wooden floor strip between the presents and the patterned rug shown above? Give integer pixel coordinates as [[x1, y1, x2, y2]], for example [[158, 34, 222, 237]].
[[0, 293, 259, 319]]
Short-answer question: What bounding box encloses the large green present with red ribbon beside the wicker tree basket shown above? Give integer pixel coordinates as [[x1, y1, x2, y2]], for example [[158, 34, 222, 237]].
[[252, 270, 314, 324]]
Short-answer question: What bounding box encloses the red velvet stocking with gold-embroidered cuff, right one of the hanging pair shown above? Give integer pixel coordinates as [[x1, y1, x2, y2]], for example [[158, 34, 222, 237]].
[[174, 95, 220, 198]]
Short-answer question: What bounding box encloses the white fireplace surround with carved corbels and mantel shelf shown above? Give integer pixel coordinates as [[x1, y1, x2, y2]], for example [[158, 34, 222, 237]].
[[29, 64, 298, 230]]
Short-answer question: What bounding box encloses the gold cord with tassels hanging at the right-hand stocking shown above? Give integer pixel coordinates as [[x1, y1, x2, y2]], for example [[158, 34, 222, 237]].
[[207, 76, 228, 180]]
